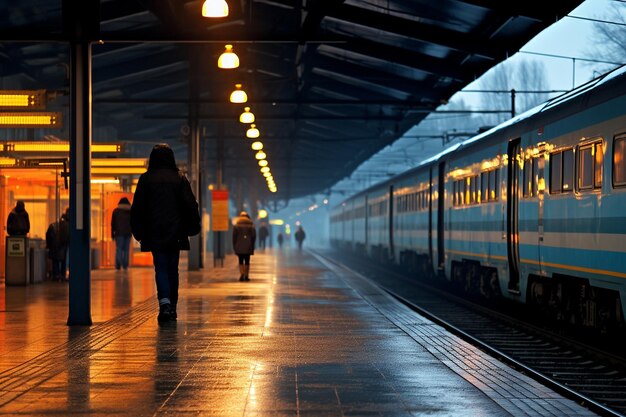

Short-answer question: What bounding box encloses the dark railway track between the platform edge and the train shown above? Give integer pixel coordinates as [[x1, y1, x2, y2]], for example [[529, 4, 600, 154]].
[[314, 253, 626, 416]]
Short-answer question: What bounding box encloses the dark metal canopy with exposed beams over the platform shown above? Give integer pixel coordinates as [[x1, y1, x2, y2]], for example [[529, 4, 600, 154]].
[[0, 0, 582, 201]]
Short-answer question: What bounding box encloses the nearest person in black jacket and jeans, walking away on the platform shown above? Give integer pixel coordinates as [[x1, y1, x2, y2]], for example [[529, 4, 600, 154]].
[[130, 144, 201, 323]]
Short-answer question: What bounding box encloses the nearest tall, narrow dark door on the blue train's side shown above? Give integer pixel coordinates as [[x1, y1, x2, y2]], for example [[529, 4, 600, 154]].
[[506, 138, 520, 293]]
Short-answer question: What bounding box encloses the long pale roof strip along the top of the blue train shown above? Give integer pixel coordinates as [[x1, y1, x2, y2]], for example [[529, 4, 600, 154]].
[[339, 65, 626, 210]]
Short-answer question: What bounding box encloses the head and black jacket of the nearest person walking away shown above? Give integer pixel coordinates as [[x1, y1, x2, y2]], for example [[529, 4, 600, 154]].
[[130, 146, 200, 252]]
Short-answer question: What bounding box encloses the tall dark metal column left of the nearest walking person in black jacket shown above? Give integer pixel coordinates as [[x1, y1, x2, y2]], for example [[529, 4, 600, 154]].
[[63, 0, 99, 325]]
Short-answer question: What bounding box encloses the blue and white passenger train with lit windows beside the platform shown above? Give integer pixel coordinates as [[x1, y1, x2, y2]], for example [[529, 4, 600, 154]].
[[330, 67, 626, 331]]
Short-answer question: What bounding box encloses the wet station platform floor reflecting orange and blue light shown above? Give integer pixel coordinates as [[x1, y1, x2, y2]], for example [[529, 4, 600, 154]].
[[0, 248, 594, 416]]
